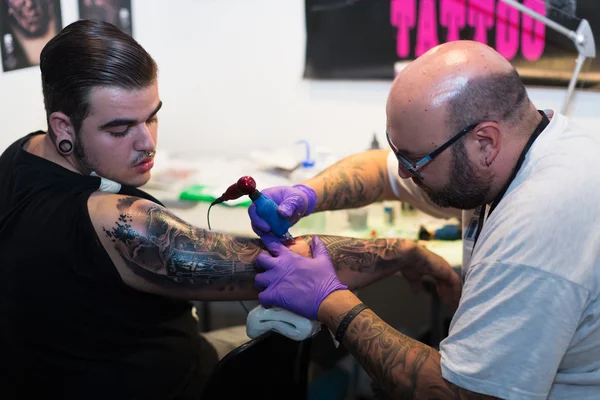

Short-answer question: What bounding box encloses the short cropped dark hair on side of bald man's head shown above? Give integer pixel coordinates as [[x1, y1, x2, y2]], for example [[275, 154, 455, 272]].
[[447, 69, 529, 135]]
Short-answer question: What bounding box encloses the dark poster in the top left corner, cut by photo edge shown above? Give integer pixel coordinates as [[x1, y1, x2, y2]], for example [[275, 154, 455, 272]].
[[0, 0, 63, 72]]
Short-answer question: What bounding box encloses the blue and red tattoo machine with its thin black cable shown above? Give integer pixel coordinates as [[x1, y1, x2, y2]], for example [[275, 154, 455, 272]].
[[207, 176, 294, 241]]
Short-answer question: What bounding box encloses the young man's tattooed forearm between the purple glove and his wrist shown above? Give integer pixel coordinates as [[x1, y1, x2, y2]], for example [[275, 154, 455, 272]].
[[302, 235, 422, 290]]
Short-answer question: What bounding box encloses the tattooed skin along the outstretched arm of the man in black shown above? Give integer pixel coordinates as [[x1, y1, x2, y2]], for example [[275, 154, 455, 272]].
[[103, 197, 432, 291]]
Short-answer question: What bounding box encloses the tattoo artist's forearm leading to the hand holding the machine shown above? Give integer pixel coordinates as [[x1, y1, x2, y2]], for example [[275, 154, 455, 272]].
[[303, 150, 394, 211]]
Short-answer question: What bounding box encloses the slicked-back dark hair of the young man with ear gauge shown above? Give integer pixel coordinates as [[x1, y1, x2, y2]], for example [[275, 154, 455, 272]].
[[40, 20, 158, 137]]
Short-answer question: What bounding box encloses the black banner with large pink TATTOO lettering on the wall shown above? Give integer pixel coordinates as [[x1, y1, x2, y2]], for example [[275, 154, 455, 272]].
[[304, 0, 600, 89]]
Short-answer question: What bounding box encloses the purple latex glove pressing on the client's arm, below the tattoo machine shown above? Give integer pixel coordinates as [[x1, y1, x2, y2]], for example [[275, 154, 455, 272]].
[[254, 235, 348, 321]]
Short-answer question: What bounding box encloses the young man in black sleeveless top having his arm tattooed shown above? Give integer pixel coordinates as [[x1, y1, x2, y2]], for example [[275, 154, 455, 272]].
[[0, 20, 460, 400]]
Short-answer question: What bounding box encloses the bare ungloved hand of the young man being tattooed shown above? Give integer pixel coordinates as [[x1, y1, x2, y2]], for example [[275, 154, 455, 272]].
[[401, 246, 462, 308]]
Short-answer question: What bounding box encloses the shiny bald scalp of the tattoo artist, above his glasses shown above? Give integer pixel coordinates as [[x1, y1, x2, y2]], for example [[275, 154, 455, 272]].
[[387, 40, 527, 134]]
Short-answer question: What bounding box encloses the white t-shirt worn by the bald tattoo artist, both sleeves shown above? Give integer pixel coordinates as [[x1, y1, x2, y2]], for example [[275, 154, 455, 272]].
[[388, 108, 600, 399]]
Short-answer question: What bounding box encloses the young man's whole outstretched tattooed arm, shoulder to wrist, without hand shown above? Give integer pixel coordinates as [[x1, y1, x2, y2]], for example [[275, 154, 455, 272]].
[[88, 193, 459, 300]]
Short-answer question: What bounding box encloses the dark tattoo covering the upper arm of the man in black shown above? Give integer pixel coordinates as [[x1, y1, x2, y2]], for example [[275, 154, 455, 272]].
[[103, 198, 262, 290]]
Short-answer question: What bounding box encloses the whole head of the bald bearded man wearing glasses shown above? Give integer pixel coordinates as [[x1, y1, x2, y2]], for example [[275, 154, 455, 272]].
[[386, 41, 541, 209]]
